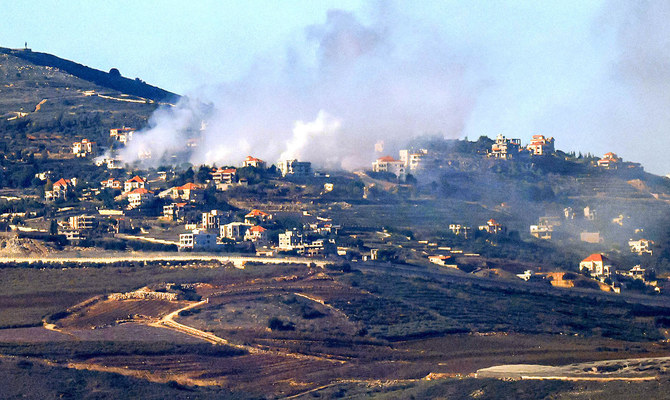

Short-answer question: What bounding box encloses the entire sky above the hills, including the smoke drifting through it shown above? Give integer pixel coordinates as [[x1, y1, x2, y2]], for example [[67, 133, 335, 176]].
[[0, 0, 670, 175]]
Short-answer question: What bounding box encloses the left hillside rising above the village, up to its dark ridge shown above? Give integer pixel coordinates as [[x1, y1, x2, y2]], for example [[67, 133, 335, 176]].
[[0, 48, 176, 153]]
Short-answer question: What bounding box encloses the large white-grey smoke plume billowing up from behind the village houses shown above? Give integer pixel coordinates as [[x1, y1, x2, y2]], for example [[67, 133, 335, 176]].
[[122, 8, 475, 169]]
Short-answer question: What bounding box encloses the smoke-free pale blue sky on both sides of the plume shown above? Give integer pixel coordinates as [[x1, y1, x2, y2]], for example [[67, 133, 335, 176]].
[[5, 0, 670, 174]]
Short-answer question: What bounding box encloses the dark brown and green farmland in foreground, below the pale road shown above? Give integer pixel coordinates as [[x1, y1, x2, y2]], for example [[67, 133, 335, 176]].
[[0, 263, 670, 398]]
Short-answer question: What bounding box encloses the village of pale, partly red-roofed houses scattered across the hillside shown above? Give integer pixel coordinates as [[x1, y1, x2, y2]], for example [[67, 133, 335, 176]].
[[0, 127, 666, 294]]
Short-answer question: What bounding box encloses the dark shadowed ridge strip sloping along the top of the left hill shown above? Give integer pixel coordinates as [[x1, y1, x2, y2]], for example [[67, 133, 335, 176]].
[[0, 47, 179, 102]]
